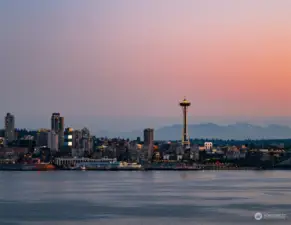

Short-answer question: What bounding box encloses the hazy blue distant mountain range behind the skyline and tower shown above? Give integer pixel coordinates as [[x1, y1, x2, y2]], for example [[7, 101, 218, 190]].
[[97, 123, 291, 140]]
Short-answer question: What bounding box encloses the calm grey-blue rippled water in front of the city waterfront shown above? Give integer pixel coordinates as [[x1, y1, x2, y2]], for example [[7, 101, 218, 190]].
[[0, 171, 291, 225]]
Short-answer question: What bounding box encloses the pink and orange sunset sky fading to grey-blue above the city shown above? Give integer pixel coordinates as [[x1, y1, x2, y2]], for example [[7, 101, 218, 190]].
[[0, 0, 291, 130]]
